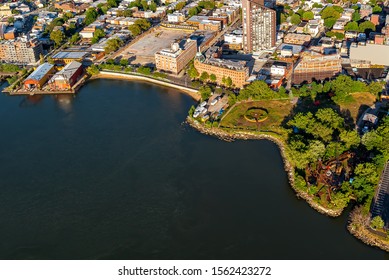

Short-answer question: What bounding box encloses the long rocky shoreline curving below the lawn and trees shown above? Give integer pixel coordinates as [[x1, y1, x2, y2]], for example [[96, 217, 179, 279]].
[[186, 117, 343, 217]]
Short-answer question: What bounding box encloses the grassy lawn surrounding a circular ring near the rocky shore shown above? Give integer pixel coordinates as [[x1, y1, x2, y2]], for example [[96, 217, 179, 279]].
[[220, 100, 293, 138]]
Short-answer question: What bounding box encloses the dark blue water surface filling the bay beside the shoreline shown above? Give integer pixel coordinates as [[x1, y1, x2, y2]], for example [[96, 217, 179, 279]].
[[0, 80, 389, 259]]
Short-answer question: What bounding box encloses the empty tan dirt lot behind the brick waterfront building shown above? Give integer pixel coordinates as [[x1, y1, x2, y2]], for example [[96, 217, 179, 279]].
[[120, 28, 189, 65]]
